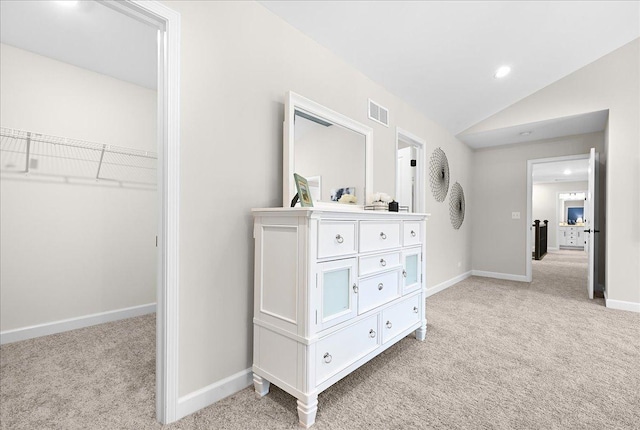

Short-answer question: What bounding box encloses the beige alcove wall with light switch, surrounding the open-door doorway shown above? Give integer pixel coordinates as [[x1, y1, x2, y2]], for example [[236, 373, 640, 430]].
[[471, 133, 604, 276]]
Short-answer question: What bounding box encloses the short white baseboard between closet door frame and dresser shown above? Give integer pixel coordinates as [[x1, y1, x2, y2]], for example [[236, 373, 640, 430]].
[[176, 369, 253, 420]]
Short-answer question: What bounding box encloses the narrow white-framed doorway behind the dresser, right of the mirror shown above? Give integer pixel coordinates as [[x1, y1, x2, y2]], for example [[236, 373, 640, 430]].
[[395, 128, 426, 212]]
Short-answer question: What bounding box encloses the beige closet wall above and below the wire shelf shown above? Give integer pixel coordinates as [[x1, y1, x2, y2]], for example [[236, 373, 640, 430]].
[[0, 44, 158, 333]]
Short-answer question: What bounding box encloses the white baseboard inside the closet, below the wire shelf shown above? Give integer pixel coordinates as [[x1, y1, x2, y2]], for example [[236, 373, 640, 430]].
[[0, 303, 156, 345]]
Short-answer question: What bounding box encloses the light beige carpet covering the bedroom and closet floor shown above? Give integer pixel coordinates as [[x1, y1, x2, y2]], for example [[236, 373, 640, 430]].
[[0, 251, 640, 430]]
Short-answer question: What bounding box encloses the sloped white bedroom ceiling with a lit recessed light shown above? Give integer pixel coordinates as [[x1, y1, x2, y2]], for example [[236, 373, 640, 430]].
[[260, 1, 640, 135]]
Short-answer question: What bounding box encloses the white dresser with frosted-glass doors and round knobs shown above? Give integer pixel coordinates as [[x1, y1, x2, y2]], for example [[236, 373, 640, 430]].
[[253, 208, 427, 427]]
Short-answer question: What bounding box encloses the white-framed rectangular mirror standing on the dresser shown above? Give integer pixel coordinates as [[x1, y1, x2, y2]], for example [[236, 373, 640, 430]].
[[282, 92, 373, 209]]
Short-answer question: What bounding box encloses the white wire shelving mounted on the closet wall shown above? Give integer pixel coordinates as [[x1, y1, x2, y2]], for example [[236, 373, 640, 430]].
[[0, 127, 158, 187]]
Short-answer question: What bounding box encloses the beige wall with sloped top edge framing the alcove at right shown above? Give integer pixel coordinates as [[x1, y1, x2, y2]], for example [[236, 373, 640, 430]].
[[465, 39, 640, 305]]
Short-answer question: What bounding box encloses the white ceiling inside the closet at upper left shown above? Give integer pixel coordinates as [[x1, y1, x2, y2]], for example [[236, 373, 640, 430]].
[[0, 0, 158, 89]]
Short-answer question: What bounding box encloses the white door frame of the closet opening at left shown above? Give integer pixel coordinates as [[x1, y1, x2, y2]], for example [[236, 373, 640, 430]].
[[101, 0, 180, 424]]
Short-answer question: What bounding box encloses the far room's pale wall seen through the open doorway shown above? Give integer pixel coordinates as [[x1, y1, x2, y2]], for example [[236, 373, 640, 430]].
[[531, 182, 588, 248]]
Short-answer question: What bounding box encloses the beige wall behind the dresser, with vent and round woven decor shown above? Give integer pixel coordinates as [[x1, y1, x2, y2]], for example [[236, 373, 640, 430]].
[[166, 1, 472, 396]]
